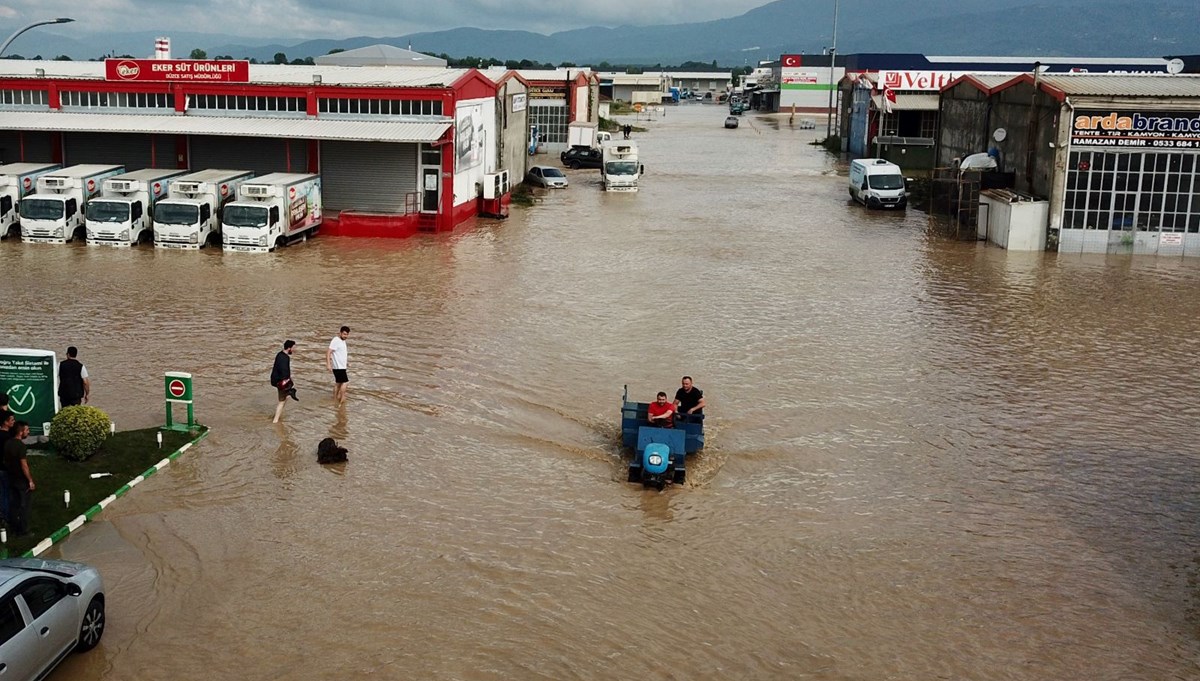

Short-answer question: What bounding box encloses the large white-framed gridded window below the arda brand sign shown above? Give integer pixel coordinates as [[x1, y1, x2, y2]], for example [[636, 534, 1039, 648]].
[[1062, 151, 1200, 234]]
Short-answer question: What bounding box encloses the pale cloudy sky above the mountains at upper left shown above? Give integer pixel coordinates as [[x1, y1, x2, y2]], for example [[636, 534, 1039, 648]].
[[0, 0, 769, 38]]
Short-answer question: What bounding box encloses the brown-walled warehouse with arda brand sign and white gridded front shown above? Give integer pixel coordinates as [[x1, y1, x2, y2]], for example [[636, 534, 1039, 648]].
[[938, 73, 1200, 257]]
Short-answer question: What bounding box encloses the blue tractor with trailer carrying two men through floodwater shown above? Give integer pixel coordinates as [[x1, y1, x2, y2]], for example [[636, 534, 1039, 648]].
[[620, 385, 704, 489]]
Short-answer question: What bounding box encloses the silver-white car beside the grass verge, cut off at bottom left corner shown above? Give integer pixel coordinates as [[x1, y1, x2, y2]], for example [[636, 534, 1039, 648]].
[[0, 559, 104, 681]]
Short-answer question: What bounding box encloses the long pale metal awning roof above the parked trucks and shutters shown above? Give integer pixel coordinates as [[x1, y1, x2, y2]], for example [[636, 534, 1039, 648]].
[[0, 112, 451, 141]]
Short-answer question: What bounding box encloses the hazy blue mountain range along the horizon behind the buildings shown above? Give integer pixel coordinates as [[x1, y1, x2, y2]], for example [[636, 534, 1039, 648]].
[[8, 0, 1200, 67]]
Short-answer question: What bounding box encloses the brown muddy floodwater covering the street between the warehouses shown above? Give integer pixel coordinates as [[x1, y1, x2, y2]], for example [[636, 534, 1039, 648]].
[[7, 104, 1200, 680]]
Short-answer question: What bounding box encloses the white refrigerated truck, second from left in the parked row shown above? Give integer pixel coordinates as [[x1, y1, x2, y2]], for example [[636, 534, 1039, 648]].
[[20, 165, 125, 243]]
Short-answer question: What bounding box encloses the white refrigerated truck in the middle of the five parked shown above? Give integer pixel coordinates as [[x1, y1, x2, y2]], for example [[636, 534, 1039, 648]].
[[84, 168, 187, 246]]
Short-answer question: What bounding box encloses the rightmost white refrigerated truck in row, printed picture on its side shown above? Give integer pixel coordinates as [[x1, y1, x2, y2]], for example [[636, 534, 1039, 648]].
[[221, 173, 322, 253]]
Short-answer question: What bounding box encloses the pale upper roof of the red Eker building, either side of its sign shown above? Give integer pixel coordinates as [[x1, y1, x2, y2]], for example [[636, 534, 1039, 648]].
[[0, 59, 468, 88]]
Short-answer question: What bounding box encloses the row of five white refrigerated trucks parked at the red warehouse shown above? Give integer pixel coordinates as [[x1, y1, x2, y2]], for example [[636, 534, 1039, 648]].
[[0, 163, 322, 252]]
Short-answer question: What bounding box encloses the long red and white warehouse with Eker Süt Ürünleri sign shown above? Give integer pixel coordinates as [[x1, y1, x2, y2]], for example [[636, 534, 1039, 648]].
[[0, 59, 501, 236]]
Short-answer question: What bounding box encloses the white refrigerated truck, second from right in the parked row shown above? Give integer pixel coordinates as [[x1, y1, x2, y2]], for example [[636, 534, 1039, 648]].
[[154, 168, 254, 248]]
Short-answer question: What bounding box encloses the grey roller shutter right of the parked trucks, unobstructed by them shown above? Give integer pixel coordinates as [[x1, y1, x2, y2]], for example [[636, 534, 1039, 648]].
[[320, 141, 418, 213]]
